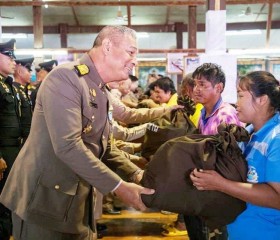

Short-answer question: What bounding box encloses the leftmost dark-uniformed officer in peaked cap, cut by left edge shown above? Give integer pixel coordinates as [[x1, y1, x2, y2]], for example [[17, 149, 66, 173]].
[[0, 39, 22, 240]]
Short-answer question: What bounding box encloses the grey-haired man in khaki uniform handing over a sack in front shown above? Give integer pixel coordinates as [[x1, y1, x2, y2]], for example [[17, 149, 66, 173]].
[[0, 26, 154, 240]]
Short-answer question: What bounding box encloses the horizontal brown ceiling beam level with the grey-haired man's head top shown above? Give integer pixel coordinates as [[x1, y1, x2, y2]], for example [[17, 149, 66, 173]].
[[2, 21, 280, 34]]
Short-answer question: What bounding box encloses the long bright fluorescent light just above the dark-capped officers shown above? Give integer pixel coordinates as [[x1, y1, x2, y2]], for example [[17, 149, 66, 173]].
[[15, 48, 68, 57]]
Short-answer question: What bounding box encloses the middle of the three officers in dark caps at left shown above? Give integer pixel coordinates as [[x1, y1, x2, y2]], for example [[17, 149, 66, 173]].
[[13, 57, 34, 143]]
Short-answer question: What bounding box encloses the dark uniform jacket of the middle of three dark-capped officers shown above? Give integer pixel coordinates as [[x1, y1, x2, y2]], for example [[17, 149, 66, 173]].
[[13, 82, 33, 139]]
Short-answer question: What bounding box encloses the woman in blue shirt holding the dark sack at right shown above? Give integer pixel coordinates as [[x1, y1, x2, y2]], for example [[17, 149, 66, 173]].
[[190, 71, 280, 240]]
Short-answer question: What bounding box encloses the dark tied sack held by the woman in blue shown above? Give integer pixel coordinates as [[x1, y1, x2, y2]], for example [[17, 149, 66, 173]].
[[141, 124, 249, 229]]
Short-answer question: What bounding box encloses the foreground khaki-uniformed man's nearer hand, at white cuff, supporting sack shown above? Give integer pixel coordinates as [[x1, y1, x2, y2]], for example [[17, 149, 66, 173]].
[[114, 182, 155, 211]]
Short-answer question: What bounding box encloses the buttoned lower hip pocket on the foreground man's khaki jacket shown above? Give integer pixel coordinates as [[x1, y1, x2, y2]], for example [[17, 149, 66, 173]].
[[28, 173, 79, 221]]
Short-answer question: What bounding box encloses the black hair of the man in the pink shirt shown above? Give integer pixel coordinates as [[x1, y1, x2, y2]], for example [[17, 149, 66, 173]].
[[192, 63, 226, 87]]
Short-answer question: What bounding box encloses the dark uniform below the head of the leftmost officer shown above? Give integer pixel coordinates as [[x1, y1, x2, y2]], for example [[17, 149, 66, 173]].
[[0, 76, 22, 240]]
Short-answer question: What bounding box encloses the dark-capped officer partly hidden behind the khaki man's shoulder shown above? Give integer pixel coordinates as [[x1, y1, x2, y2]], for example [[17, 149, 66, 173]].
[[30, 60, 58, 110]]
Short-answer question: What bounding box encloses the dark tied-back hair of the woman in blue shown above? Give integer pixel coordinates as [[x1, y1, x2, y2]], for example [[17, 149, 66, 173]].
[[238, 71, 280, 111]]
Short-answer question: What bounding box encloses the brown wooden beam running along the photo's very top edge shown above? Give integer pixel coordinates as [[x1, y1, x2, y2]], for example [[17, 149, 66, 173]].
[[0, 0, 280, 7]]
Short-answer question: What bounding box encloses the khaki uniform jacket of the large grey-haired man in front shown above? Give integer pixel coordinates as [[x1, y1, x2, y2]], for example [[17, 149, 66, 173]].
[[0, 54, 138, 233]]
